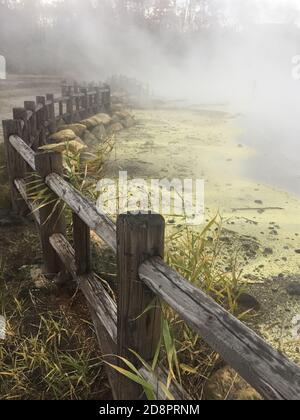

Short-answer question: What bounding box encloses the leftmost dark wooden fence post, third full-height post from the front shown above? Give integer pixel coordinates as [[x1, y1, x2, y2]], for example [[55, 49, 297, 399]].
[[2, 120, 28, 215]]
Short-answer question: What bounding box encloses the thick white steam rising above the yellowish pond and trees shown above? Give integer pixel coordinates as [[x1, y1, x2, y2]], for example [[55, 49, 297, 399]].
[[0, 0, 300, 192]]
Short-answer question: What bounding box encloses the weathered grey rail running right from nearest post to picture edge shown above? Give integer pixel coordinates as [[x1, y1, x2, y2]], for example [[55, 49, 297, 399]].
[[139, 258, 300, 400]]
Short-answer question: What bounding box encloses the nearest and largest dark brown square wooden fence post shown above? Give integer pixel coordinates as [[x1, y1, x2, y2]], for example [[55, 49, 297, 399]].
[[117, 213, 165, 400]]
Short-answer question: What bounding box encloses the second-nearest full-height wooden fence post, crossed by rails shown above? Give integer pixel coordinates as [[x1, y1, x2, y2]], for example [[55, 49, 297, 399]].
[[35, 151, 66, 276]]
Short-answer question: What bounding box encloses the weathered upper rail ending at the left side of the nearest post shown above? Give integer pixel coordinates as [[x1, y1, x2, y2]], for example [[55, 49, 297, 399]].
[[45, 173, 117, 251]]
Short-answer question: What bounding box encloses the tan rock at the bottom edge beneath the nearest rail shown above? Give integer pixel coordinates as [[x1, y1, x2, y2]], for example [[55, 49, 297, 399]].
[[204, 367, 262, 401]]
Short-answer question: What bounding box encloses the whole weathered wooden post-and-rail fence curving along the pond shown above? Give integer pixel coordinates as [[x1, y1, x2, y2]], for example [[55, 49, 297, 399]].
[[3, 81, 300, 400]]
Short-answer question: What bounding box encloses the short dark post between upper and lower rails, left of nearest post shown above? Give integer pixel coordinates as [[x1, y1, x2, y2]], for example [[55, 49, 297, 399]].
[[73, 213, 91, 276]]
